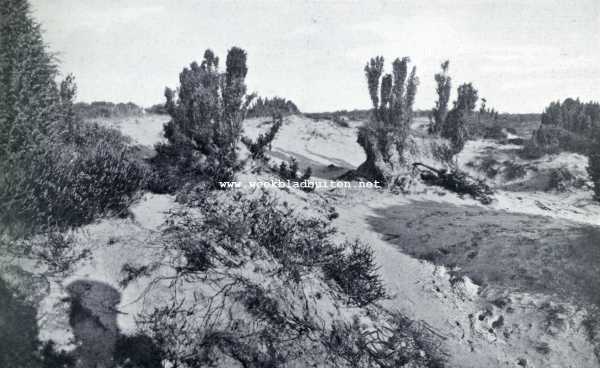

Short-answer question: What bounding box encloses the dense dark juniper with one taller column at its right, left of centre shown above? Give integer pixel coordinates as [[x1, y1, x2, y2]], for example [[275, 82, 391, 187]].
[[153, 47, 253, 191]]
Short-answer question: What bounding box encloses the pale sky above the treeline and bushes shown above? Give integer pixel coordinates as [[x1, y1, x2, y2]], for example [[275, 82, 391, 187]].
[[31, 0, 600, 112]]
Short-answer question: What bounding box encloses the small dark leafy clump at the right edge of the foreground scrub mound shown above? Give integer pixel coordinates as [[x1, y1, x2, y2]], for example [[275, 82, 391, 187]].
[[324, 241, 386, 307]]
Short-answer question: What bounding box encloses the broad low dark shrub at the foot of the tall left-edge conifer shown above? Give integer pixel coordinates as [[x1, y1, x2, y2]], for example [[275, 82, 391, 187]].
[[0, 125, 147, 234]]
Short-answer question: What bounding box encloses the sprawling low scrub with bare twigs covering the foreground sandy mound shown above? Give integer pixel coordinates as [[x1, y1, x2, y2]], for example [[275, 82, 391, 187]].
[[124, 191, 439, 367]]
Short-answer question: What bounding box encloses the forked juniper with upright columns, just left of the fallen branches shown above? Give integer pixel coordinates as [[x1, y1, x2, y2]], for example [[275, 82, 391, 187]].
[[357, 56, 419, 184]]
